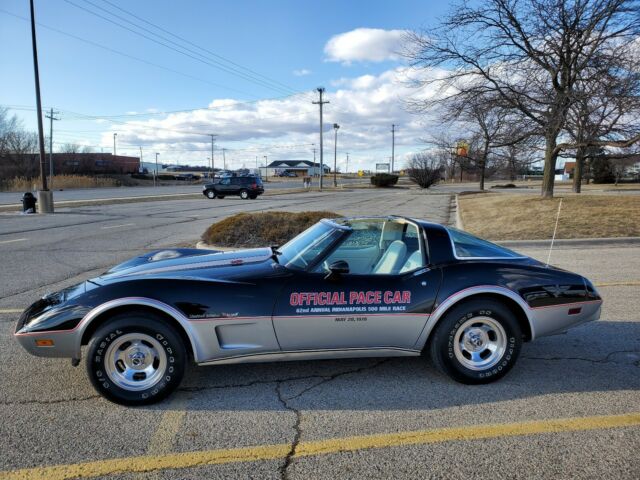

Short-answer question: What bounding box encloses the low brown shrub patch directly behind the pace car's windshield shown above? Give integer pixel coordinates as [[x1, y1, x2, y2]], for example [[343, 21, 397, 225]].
[[202, 212, 340, 247]]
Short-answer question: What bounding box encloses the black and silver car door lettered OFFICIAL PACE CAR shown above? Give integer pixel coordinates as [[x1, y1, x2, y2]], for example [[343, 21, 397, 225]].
[[273, 219, 442, 351]]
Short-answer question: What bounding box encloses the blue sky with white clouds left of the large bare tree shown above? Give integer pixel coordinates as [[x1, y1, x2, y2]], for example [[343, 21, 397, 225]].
[[0, 0, 447, 168]]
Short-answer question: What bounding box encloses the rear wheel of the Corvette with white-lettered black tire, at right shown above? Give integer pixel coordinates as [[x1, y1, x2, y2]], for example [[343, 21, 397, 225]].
[[429, 298, 522, 384]]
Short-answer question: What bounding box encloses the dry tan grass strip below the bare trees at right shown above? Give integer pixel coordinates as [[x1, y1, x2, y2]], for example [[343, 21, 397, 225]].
[[458, 194, 640, 240]]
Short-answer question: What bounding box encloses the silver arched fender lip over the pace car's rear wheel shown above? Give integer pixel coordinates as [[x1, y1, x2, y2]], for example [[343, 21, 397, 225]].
[[416, 286, 535, 350]]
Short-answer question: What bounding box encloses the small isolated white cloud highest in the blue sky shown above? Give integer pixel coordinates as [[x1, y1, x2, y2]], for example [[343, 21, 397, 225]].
[[324, 28, 405, 65]]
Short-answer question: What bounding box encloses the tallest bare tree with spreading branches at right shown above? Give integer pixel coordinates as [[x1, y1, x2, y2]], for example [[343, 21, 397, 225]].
[[406, 0, 640, 197]]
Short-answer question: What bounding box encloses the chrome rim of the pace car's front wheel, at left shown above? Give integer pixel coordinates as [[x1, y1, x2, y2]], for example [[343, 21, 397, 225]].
[[105, 333, 167, 391]]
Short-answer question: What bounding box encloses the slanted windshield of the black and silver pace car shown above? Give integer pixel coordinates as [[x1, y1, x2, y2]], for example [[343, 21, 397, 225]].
[[278, 221, 348, 270]]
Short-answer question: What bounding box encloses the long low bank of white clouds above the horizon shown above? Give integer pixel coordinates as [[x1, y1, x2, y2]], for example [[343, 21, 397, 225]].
[[101, 68, 444, 169]]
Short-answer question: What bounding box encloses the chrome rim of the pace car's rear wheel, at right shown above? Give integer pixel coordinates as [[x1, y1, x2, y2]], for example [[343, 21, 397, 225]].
[[453, 317, 507, 370]]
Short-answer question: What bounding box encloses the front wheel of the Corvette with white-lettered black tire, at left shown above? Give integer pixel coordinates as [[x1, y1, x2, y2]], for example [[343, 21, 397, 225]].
[[87, 311, 187, 406]]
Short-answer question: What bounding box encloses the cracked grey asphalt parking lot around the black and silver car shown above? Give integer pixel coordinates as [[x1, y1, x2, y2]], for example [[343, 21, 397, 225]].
[[0, 190, 640, 480]]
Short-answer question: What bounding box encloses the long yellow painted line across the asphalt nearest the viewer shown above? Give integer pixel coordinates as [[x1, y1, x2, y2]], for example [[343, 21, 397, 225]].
[[0, 413, 640, 480]]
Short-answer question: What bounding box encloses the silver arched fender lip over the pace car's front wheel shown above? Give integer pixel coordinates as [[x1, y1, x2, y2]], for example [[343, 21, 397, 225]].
[[76, 298, 198, 362]]
